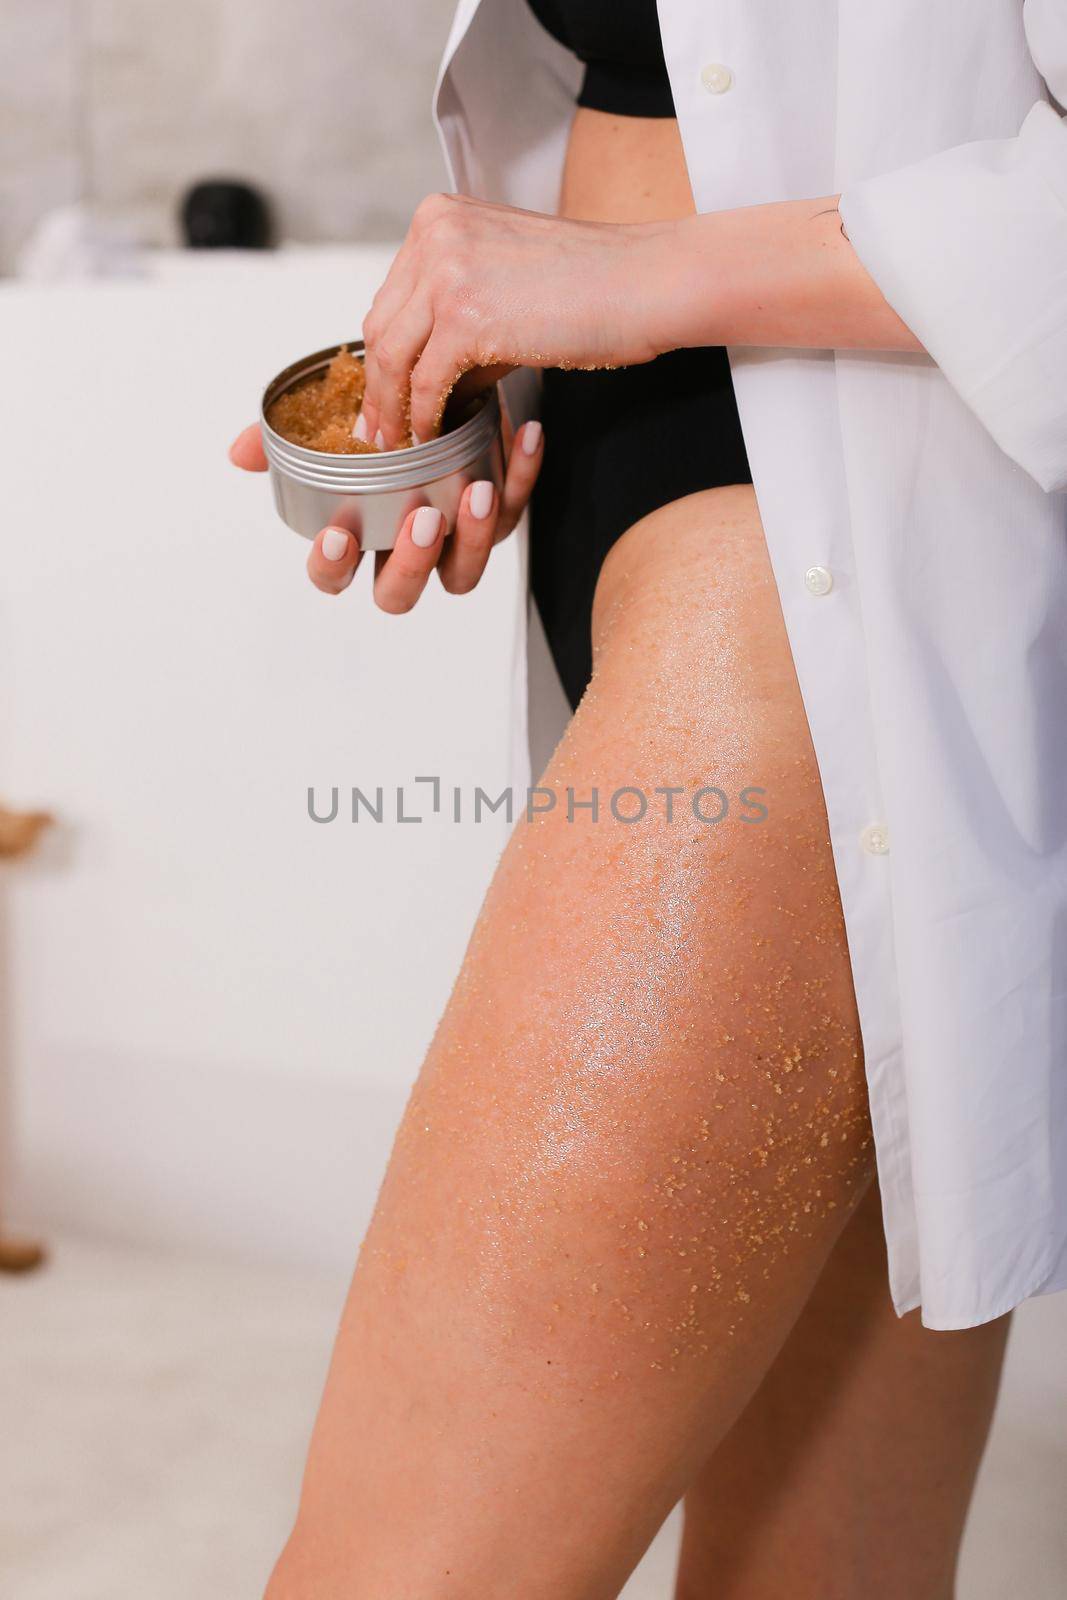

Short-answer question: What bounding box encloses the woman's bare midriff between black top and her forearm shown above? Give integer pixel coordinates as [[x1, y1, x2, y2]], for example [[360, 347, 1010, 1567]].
[[560, 106, 696, 222]]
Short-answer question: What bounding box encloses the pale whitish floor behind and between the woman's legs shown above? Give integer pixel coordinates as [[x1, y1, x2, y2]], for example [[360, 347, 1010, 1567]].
[[0, 1238, 1067, 1600]]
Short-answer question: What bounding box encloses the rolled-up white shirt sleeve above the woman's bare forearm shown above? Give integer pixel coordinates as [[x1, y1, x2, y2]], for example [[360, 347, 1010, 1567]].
[[838, 0, 1067, 491]]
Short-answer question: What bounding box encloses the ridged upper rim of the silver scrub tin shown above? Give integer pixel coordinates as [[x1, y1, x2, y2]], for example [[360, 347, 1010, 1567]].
[[259, 339, 501, 494]]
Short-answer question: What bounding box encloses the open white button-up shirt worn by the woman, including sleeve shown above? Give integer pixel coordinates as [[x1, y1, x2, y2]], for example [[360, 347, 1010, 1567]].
[[435, 0, 1067, 1328]]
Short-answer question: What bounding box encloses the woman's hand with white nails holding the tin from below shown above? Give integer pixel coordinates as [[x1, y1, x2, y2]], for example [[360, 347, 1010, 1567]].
[[230, 409, 544, 613]]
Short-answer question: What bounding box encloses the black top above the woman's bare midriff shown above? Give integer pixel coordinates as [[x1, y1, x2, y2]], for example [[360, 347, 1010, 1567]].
[[528, 0, 675, 117]]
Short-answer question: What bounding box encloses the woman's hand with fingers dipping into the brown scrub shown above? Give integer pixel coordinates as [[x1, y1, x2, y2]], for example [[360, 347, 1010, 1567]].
[[362, 195, 675, 448]]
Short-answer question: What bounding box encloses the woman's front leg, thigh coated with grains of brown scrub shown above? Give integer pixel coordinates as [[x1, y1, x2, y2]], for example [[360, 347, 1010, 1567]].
[[269, 488, 872, 1600]]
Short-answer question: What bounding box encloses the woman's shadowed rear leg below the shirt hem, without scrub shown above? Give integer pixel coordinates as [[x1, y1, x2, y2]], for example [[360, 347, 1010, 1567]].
[[675, 1184, 1009, 1600]]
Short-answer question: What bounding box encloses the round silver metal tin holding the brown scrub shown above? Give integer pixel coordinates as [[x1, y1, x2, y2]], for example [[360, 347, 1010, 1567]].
[[259, 339, 504, 550]]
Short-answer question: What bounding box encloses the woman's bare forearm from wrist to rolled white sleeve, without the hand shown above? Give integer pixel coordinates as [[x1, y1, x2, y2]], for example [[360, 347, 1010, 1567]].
[[664, 195, 923, 350]]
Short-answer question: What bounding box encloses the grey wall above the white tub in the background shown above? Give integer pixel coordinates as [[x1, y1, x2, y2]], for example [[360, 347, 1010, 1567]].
[[0, 0, 453, 270]]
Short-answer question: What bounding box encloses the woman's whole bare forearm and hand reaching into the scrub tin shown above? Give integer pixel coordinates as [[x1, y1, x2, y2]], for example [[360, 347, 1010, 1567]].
[[351, 194, 921, 450]]
